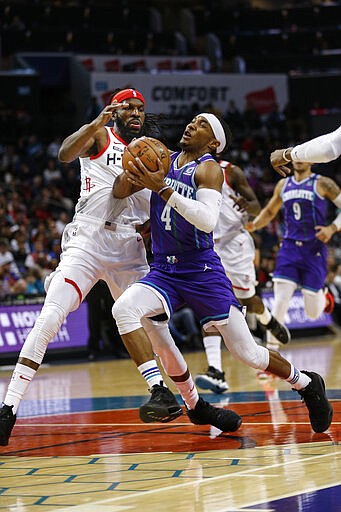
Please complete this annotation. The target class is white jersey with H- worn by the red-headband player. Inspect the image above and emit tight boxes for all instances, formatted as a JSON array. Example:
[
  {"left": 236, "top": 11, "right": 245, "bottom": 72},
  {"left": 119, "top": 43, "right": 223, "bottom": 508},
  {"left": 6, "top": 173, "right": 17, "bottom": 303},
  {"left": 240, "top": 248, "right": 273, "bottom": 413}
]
[{"left": 75, "top": 127, "right": 150, "bottom": 225}]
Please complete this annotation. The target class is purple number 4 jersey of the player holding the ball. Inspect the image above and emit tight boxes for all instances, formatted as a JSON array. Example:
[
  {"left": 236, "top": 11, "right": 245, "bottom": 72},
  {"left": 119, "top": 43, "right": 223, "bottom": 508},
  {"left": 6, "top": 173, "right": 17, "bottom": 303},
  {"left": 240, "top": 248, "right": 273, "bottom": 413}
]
[{"left": 150, "top": 152, "right": 215, "bottom": 256}]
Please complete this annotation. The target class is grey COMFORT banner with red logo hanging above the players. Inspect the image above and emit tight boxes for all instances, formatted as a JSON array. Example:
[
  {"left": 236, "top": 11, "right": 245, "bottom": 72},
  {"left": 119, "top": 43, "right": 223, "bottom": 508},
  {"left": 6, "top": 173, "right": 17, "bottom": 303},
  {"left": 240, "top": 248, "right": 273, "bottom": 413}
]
[{"left": 91, "top": 72, "right": 288, "bottom": 119}]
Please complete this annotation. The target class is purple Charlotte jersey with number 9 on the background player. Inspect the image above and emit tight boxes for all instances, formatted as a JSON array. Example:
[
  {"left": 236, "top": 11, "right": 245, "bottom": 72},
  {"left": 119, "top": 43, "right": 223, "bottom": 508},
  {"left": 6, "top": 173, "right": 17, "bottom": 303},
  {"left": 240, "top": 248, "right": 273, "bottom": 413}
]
[{"left": 281, "top": 174, "right": 327, "bottom": 241}]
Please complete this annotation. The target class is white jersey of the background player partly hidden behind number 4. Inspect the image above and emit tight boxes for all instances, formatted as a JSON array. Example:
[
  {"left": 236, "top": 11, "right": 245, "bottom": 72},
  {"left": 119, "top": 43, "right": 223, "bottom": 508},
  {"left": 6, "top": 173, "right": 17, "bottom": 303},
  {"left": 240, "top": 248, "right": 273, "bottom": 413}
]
[{"left": 213, "top": 160, "right": 249, "bottom": 242}]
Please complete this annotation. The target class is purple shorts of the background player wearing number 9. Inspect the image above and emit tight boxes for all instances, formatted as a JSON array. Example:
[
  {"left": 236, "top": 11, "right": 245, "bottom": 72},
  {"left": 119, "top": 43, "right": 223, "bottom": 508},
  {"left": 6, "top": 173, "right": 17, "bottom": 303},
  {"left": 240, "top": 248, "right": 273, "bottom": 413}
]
[{"left": 273, "top": 239, "right": 328, "bottom": 292}]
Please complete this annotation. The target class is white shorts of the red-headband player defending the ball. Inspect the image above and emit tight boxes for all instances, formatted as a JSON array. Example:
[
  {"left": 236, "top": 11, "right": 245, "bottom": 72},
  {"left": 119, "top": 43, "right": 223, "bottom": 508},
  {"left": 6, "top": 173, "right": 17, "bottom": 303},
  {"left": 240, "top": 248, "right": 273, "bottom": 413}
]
[{"left": 45, "top": 218, "right": 149, "bottom": 302}]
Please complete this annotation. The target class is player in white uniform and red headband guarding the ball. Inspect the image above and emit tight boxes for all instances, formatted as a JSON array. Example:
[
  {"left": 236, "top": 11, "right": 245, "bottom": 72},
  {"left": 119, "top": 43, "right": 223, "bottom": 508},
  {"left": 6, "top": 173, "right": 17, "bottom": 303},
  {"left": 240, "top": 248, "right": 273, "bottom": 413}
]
[{"left": 0, "top": 89, "right": 181, "bottom": 446}]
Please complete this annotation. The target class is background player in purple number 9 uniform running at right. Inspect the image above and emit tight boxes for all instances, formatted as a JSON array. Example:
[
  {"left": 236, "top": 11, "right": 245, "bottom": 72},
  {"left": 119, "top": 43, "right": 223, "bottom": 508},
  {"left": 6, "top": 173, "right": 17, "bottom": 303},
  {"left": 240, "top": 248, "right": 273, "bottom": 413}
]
[{"left": 247, "top": 162, "right": 341, "bottom": 348}]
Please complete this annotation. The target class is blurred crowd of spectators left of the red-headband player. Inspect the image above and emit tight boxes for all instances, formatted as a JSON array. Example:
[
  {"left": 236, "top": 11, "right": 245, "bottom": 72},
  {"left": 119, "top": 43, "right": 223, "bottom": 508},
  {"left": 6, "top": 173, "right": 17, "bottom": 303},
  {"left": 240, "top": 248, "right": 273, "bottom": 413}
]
[{"left": 0, "top": 134, "right": 79, "bottom": 300}]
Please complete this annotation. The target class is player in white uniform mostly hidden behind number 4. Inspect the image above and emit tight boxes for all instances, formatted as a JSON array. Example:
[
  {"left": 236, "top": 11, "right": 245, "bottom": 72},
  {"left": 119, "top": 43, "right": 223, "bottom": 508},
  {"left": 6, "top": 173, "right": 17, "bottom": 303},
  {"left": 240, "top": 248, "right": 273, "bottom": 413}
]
[{"left": 195, "top": 160, "right": 290, "bottom": 393}]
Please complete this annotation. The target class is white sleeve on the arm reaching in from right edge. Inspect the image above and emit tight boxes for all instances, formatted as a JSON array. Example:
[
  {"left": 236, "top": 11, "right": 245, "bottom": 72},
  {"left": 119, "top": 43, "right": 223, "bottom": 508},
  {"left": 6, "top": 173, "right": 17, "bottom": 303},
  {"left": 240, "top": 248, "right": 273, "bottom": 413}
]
[{"left": 291, "top": 126, "right": 341, "bottom": 163}]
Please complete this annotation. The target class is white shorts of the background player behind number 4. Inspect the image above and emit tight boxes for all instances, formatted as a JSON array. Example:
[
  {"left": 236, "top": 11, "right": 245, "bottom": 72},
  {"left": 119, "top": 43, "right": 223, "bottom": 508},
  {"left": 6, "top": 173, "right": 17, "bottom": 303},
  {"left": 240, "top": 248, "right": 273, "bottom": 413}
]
[{"left": 214, "top": 231, "right": 257, "bottom": 299}]
